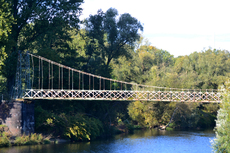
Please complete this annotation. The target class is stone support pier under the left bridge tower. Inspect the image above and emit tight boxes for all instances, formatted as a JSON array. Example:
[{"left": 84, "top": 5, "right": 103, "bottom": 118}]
[{"left": 0, "top": 101, "right": 35, "bottom": 136}]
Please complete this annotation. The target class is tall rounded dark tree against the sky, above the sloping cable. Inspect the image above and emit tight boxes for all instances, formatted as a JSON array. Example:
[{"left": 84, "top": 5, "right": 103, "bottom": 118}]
[{"left": 85, "top": 8, "right": 143, "bottom": 74}]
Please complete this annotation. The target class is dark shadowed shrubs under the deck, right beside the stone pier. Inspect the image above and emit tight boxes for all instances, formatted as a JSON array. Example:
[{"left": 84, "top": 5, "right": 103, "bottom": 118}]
[{"left": 35, "top": 100, "right": 129, "bottom": 141}]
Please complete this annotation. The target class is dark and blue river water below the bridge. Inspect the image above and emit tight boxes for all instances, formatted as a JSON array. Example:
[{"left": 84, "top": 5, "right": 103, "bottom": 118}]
[{"left": 0, "top": 129, "right": 215, "bottom": 153}]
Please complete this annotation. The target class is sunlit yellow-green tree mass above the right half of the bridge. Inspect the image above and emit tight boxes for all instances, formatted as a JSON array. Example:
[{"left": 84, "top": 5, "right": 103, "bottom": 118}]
[{"left": 112, "top": 38, "right": 230, "bottom": 89}]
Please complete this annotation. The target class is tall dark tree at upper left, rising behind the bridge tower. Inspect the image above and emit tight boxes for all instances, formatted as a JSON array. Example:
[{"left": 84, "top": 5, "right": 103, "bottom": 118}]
[{"left": 0, "top": 0, "right": 83, "bottom": 92}]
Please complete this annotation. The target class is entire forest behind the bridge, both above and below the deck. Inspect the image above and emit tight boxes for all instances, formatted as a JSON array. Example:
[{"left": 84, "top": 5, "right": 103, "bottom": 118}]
[{"left": 0, "top": 0, "right": 230, "bottom": 149}]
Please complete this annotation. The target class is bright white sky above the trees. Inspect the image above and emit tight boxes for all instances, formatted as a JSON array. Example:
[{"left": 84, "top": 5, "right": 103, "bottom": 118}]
[{"left": 80, "top": 0, "right": 230, "bottom": 57}]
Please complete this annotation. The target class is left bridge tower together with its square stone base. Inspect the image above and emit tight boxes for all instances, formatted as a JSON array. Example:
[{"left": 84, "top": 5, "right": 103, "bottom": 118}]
[{"left": 0, "top": 51, "right": 34, "bottom": 136}]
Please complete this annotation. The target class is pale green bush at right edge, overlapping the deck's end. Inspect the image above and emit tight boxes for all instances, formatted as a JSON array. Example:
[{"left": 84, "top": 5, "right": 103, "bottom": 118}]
[{"left": 212, "top": 81, "right": 230, "bottom": 153}]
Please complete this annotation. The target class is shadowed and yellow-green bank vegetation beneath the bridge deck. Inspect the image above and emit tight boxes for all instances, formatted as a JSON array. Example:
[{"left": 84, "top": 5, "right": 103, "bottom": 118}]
[{"left": 2, "top": 100, "right": 218, "bottom": 146}]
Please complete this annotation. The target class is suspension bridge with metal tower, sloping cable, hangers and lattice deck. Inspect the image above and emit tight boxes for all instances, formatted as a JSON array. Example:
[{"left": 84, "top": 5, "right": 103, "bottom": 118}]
[{"left": 12, "top": 52, "right": 222, "bottom": 103}]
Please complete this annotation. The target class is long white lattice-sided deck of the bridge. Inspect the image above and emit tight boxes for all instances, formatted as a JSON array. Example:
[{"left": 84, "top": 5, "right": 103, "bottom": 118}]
[{"left": 23, "top": 89, "right": 222, "bottom": 103}]
